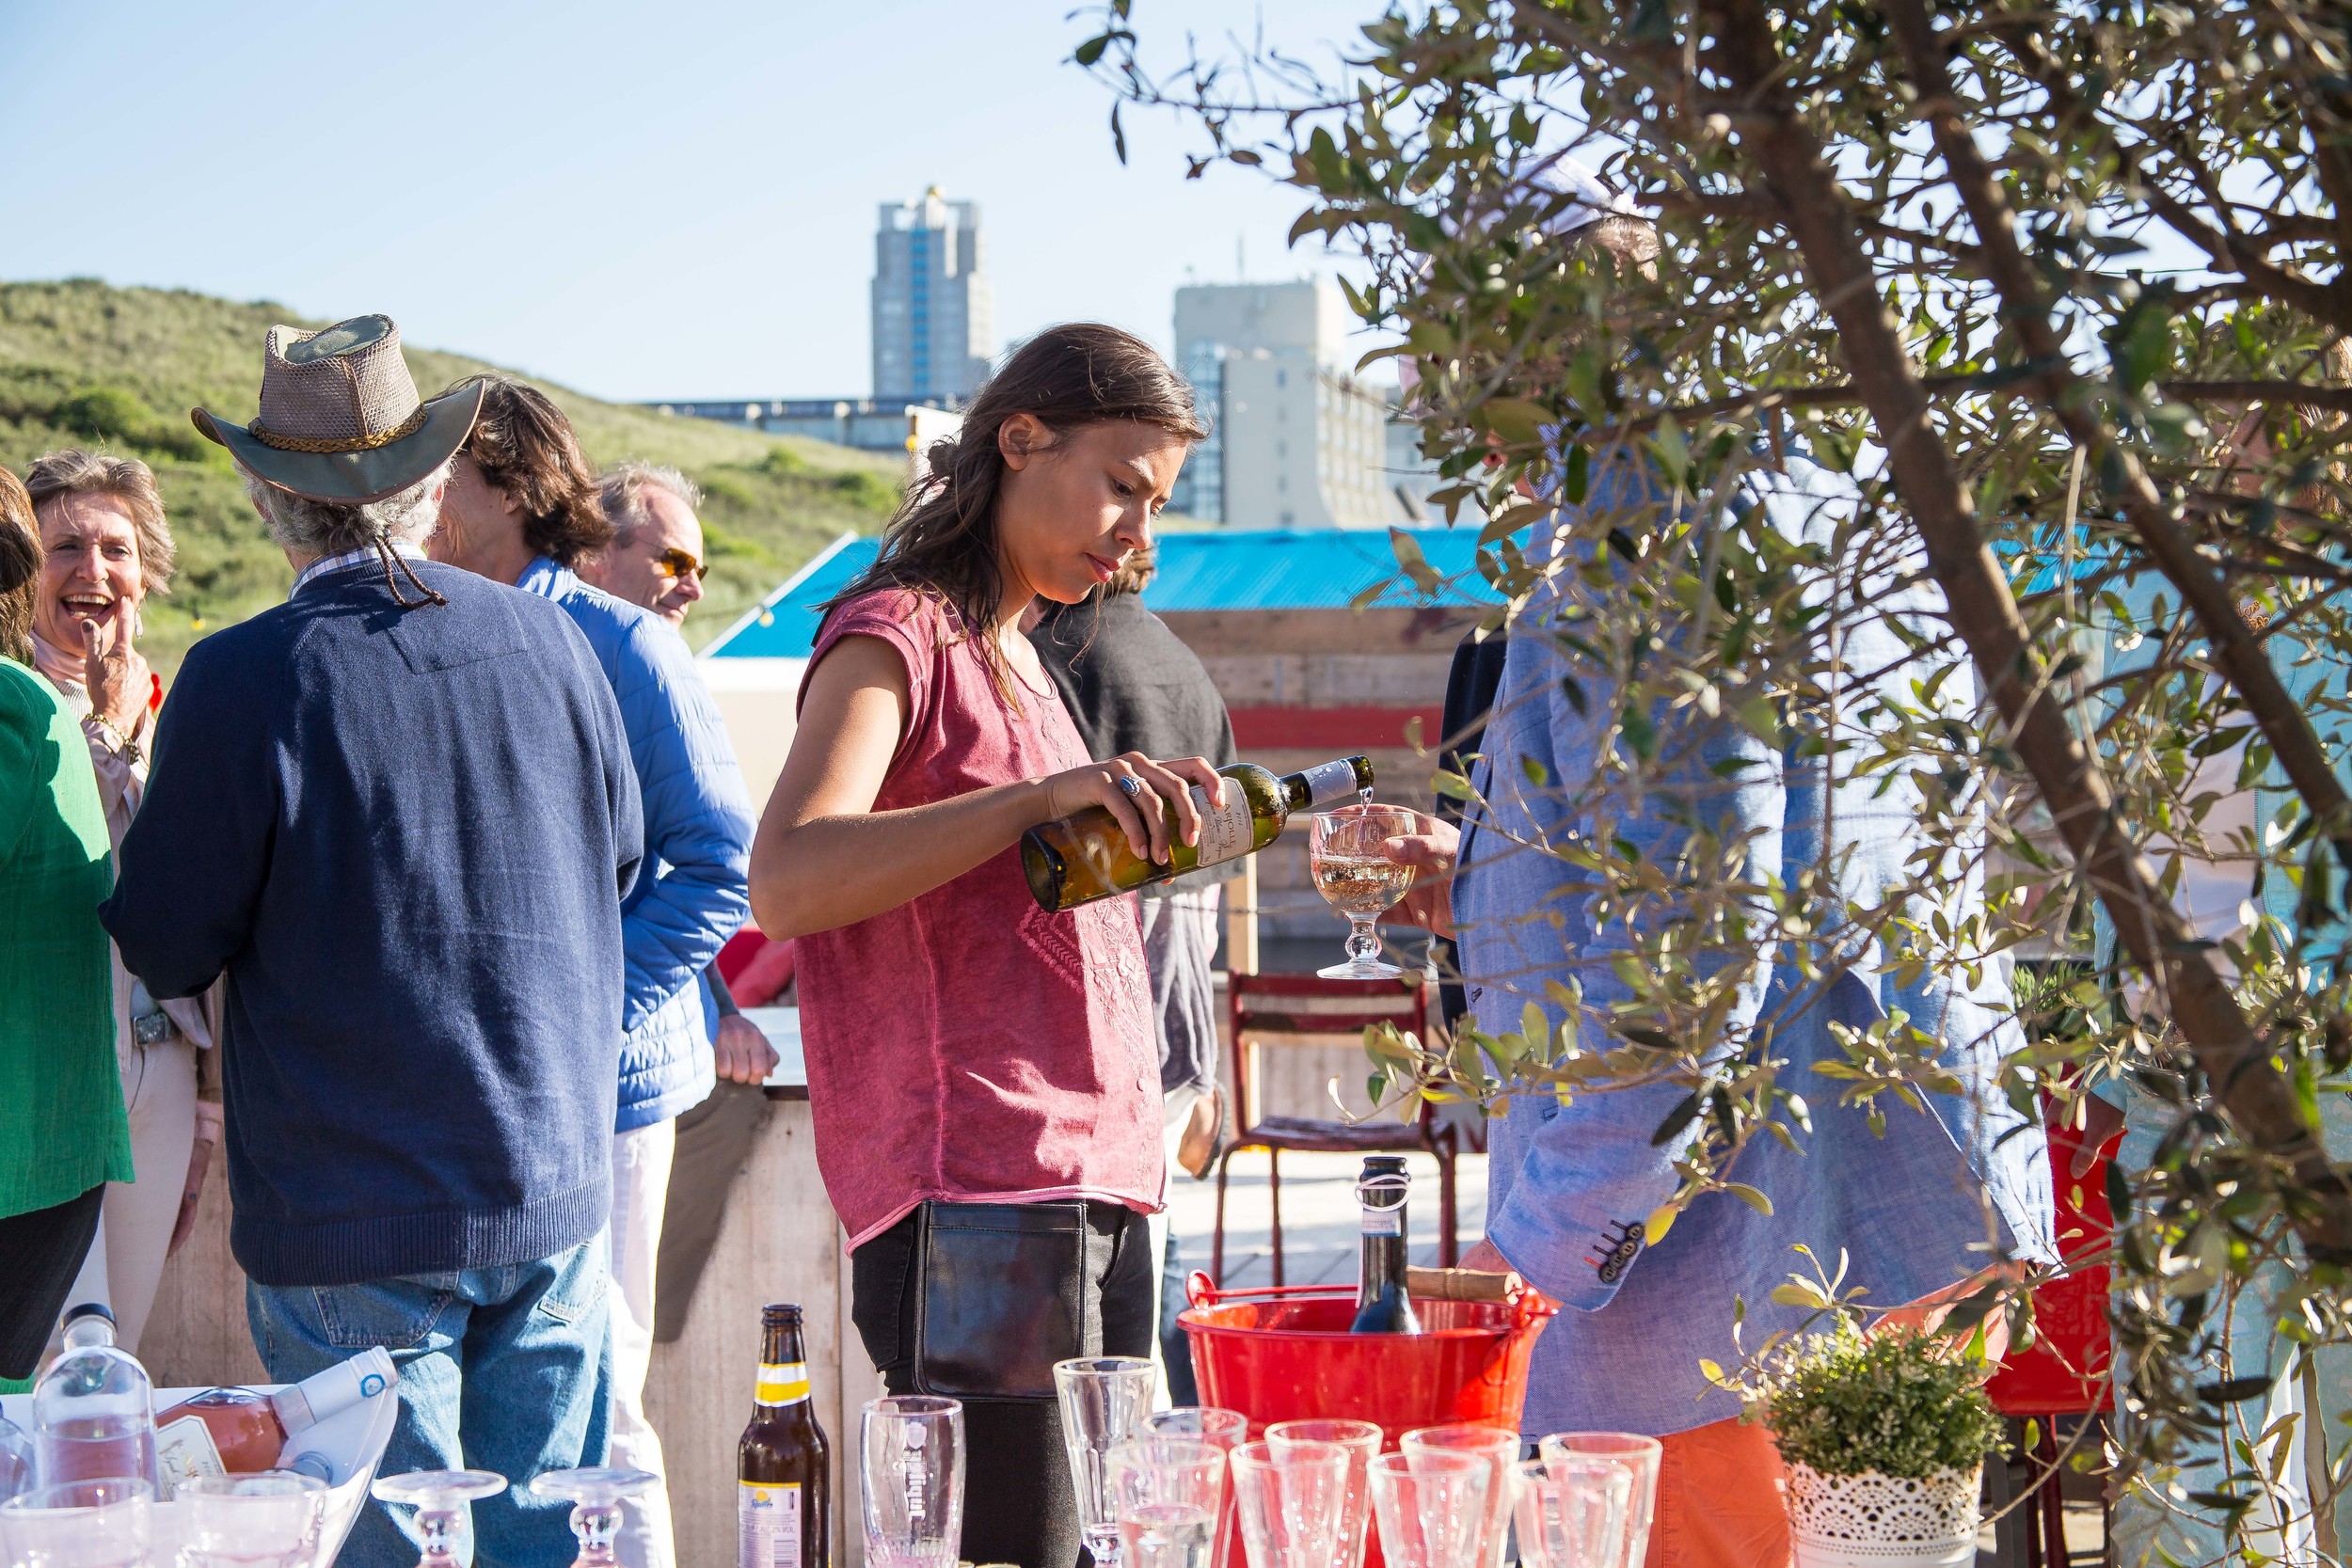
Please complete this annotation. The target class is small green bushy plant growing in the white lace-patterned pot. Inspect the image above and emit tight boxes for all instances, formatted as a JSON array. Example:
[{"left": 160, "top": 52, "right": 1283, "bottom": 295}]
[{"left": 1750, "top": 1323, "right": 2002, "bottom": 1477}]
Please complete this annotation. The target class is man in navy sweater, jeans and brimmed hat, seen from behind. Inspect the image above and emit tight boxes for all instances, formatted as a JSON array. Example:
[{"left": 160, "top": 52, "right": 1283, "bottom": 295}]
[{"left": 103, "top": 317, "right": 644, "bottom": 1568}]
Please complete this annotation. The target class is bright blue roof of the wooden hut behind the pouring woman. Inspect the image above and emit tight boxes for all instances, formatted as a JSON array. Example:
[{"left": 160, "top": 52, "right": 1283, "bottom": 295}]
[{"left": 704, "top": 524, "right": 1494, "bottom": 658}]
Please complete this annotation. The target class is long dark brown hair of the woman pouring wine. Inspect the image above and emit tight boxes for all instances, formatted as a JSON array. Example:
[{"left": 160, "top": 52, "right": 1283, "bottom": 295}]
[{"left": 823, "top": 322, "right": 1207, "bottom": 696}]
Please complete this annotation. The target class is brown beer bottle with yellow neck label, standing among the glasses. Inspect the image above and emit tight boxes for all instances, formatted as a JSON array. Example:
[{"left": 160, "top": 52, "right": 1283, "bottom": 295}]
[{"left": 737, "top": 1307, "right": 833, "bottom": 1568}]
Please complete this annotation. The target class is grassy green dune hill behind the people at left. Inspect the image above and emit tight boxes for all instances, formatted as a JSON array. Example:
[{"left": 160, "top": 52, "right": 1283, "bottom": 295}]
[{"left": 0, "top": 279, "right": 906, "bottom": 670}]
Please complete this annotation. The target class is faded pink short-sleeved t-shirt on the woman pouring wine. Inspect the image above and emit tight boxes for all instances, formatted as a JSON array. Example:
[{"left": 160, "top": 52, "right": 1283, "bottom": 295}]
[{"left": 795, "top": 590, "right": 1167, "bottom": 1246}]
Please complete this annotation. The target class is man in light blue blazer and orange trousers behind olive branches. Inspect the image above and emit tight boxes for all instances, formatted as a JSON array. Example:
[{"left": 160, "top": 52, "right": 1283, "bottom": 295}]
[{"left": 1383, "top": 444, "right": 2056, "bottom": 1568}]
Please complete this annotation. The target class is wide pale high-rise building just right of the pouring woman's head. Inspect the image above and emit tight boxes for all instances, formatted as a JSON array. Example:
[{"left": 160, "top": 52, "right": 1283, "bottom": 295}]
[{"left": 1169, "top": 277, "right": 1411, "bottom": 529}]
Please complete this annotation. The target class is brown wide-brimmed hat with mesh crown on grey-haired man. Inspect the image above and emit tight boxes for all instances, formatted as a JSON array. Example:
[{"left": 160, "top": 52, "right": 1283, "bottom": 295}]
[{"left": 188, "top": 315, "right": 483, "bottom": 505}]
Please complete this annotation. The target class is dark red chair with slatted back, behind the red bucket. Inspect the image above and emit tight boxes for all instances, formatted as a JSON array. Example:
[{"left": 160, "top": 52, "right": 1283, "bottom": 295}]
[{"left": 1209, "top": 974, "right": 1461, "bottom": 1286}]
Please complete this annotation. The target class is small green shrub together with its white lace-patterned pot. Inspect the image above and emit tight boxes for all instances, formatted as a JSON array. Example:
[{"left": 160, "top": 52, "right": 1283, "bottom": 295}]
[{"left": 1753, "top": 1322, "right": 2002, "bottom": 1568}]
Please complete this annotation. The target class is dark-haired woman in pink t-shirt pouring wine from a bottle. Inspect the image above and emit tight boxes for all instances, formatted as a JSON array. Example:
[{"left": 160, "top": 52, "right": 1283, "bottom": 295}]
[{"left": 751, "top": 325, "right": 1232, "bottom": 1568}]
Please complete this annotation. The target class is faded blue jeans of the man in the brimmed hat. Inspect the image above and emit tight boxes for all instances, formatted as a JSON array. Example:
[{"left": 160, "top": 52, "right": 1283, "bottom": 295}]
[{"left": 245, "top": 1234, "right": 612, "bottom": 1568}]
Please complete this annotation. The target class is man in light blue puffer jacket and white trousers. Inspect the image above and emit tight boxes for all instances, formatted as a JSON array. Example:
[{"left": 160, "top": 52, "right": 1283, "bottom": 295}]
[{"left": 431, "top": 376, "right": 753, "bottom": 1568}]
